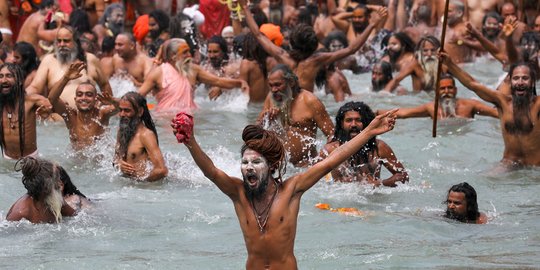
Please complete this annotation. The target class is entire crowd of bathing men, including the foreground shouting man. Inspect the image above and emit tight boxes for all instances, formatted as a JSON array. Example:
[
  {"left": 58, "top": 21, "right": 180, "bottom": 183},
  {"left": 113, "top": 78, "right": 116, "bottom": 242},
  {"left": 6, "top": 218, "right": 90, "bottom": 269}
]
[{"left": 0, "top": 0, "right": 540, "bottom": 269}]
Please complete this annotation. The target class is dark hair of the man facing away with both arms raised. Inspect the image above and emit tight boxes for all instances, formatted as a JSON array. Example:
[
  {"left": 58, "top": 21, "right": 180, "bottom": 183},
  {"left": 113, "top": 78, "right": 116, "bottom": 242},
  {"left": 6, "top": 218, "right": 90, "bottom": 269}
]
[{"left": 289, "top": 23, "right": 319, "bottom": 61}]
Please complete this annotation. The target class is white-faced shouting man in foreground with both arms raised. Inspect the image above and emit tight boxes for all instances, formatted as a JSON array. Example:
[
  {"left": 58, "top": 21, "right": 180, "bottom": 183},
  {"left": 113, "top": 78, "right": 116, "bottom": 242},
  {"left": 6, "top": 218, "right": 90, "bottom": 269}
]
[{"left": 173, "top": 108, "right": 395, "bottom": 269}]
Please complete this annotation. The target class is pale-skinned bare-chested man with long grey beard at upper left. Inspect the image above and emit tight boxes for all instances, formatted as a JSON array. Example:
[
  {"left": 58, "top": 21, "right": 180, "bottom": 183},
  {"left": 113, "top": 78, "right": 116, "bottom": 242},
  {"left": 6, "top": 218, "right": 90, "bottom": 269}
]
[{"left": 26, "top": 25, "right": 112, "bottom": 108}]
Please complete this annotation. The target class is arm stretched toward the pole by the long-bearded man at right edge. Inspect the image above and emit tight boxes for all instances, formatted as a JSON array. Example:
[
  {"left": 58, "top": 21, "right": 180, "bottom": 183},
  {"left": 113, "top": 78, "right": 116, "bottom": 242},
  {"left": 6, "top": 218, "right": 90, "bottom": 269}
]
[{"left": 439, "top": 52, "right": 506, "bottom": 107}]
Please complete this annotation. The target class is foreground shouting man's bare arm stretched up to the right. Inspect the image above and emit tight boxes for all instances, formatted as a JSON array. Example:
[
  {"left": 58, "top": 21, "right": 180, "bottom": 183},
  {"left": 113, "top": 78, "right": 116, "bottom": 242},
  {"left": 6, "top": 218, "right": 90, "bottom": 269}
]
[{"left": 289, "top": 110, "right": 396, "bottom": 193}]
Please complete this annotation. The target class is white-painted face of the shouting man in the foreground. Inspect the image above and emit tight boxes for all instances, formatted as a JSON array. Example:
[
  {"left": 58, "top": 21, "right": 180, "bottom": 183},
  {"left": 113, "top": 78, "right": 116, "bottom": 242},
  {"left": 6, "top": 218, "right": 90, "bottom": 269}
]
[{"left": 240, "top": 148, "right": 270, "bottom": 190}]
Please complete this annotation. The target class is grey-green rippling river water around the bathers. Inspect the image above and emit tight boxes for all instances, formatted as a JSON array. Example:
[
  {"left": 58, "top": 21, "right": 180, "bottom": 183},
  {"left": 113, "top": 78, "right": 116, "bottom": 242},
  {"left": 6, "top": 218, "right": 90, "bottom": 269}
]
[{"left": 0, "top": 60, "right": 540, "bottom": 269}]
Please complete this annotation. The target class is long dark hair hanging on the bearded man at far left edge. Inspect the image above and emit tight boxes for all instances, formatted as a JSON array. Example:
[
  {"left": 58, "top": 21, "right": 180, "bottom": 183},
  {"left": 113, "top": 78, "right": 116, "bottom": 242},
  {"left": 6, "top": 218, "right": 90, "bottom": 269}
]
[{"left": 0, "top": 63, "right": 26, "bottom": 156}]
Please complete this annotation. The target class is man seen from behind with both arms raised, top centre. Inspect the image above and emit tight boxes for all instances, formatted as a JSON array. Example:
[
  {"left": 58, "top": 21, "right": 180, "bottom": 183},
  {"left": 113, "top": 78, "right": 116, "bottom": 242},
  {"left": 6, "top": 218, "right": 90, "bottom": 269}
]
[{"left": 239, "top": 0, "right": 387, "bottom": 92}]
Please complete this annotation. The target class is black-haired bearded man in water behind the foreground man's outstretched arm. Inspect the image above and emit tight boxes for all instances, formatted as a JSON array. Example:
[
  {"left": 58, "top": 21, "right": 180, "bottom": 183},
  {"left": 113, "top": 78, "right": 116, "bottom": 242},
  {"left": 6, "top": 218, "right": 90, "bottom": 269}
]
[{"left": 320, "top": 102, "right": 409, "bottom": 187}]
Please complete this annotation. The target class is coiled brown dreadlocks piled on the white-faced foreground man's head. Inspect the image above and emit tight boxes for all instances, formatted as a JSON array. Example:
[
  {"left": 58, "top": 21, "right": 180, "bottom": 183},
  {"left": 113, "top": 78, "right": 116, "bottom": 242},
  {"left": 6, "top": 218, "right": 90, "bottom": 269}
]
[{"left": 240, "top": 125, "right": 286, "bottom": 183}]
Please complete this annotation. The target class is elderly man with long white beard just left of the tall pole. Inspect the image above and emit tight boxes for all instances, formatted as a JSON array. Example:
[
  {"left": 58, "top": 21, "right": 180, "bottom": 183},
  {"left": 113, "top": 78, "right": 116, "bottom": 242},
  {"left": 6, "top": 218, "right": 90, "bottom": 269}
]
[{"left": 384, "top": 36, "right": 441, "bottom": 92}]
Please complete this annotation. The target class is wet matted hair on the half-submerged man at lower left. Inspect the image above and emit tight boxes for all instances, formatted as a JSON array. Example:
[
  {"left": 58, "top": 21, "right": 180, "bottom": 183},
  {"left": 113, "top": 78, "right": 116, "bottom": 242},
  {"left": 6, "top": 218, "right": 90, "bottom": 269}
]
[{"left": 15, "top": 157, "right": 60, "bottom": 201}]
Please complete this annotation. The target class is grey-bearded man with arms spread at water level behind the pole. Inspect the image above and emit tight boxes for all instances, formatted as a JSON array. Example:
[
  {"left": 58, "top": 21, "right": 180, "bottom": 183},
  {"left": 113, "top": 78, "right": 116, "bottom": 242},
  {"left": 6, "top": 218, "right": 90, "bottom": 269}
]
[{"left": 377, "top": 74, "right": 498, "bottom": 119}]
